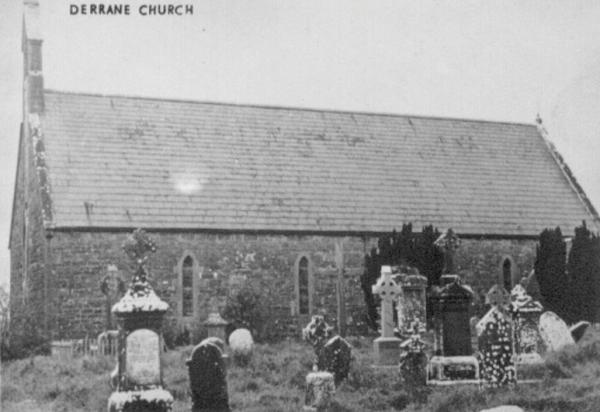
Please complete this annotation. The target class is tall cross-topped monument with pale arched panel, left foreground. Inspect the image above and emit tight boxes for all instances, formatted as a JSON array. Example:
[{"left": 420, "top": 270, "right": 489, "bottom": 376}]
[{"left": 108, "top": 229, "right": 173, "bottom": 412}]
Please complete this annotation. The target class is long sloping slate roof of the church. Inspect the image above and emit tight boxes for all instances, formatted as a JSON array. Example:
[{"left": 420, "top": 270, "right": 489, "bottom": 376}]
[{"left": 41, "top": 91, "right": 597, "bottom": 236}]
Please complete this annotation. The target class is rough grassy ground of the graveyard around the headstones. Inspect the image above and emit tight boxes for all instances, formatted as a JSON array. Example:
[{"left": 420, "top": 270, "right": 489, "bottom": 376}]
[{"left": 1, "top": 327, "right": 600, "bottom": 412}]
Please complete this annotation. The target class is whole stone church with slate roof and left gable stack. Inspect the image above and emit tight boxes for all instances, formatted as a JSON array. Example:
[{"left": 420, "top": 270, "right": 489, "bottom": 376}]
[{"left": 10, "top": 0, "right": 600, "bottom": 339}]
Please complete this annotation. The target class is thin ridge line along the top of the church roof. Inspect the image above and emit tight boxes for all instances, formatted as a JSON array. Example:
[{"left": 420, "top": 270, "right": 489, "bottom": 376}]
[{"left": 44, "top": 89, "right": 536, "bottom": 127}]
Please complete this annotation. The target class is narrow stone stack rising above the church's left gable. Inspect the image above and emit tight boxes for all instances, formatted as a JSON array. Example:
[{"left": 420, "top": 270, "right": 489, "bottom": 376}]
[{"left": 21, "top": 0, "right": 44, "bottom": 113}]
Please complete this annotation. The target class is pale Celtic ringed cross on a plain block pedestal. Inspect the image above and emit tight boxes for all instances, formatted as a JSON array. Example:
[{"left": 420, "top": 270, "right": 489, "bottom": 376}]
[{"left": 372, "top": 266, "right": 402, "bottom": 365}]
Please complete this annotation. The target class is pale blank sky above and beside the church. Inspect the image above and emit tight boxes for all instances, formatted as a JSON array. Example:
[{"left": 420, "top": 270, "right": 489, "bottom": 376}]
[{"left": 0, "top": 0, "right": 600, "bottom": 290}]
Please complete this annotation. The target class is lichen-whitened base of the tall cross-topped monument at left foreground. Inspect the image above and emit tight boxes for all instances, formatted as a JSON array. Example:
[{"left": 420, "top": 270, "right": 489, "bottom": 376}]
[{"left": 108, "top": 389, "right": 173, "bottom": 412}]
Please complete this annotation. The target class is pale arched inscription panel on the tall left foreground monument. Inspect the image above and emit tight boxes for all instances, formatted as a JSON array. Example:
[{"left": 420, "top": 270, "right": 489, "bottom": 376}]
[{"left": 125, "top": 329, "right": 160, "bottom": 385}]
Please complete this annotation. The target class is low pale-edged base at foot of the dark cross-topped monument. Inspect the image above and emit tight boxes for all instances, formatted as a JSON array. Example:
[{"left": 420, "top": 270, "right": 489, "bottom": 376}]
[{"left": 427, "top": 356, "right": 479, "bottom": 383}]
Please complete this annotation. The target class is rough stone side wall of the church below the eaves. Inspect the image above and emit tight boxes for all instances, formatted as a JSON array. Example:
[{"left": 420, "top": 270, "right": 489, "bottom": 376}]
[{"left": 44, "top": 232, "right": 536, "bottom": 339}]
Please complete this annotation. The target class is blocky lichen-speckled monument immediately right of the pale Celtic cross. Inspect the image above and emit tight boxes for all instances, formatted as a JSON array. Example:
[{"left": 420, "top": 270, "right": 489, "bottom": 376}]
[{"left": 396, "top": 275, "right": 427, "bottom": 336}]
